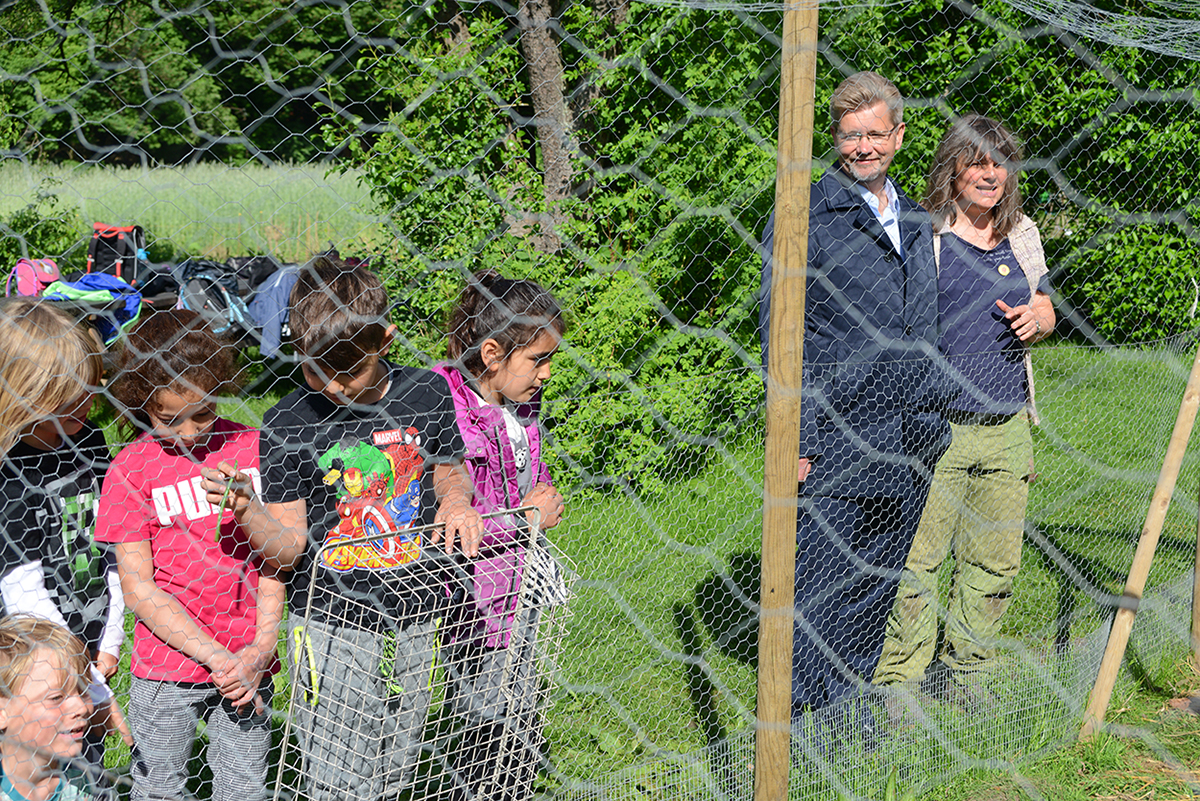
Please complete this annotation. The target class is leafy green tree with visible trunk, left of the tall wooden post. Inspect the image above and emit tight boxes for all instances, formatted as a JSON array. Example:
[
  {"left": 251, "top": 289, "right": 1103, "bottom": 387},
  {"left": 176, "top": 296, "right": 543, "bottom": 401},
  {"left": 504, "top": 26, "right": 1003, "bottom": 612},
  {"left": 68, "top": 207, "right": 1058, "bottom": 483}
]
[{"left": 326, "top": 2, "right": 778, "bottom": 493}]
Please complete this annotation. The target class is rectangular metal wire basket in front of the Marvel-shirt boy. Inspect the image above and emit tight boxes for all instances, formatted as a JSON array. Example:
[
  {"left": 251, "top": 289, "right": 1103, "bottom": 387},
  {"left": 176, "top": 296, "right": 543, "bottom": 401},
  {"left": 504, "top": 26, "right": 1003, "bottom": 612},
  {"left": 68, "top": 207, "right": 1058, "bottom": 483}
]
[{"left": 272, "top": 507, "right": 577, "bottom": 801}]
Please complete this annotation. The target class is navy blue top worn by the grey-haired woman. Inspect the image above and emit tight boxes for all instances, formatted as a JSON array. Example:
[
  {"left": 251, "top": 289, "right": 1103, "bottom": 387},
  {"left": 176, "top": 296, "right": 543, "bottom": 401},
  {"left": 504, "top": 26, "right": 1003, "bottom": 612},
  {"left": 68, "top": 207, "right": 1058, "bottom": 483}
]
[{"left": 937, "top": 234, "right": 1050, "bottom": 415}]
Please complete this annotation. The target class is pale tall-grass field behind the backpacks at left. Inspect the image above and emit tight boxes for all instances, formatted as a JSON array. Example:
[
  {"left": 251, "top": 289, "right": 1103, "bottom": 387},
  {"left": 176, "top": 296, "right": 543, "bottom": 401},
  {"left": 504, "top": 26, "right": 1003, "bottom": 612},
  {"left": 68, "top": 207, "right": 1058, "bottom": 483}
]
[{"left": 0, "top": 162, "right": 379, "bottom": 261}]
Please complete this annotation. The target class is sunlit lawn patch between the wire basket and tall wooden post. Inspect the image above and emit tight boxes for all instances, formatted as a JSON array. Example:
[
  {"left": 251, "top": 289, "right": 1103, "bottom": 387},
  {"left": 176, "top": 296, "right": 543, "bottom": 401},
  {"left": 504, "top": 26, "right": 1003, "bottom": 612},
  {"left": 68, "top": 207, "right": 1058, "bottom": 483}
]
[{"left": 548, "top": 438, "right": 762, "bottom": 777}]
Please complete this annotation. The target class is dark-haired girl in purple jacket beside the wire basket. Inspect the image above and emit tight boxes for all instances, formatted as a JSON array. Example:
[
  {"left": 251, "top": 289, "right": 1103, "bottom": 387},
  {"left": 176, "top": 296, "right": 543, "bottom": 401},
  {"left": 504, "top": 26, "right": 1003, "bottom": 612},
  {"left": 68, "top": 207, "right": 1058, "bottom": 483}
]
[{"left": 433, "top": 270, "right": 565, "bottom": 801}]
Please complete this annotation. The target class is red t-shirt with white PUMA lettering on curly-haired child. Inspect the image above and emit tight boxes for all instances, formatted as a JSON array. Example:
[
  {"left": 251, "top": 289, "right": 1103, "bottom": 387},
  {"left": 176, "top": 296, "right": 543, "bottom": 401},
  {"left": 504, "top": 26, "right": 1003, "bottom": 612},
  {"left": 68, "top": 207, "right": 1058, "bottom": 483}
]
[{"left": 96, "top": 418, "right": 278, "bottom": 682}]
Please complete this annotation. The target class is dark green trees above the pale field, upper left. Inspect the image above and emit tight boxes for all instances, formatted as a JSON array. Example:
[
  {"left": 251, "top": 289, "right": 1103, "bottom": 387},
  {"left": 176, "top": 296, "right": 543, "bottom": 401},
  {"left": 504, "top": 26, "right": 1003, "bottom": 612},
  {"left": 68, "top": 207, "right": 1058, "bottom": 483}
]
[{"left": 0, "top": 0, "right": 413, "bottom": 164}]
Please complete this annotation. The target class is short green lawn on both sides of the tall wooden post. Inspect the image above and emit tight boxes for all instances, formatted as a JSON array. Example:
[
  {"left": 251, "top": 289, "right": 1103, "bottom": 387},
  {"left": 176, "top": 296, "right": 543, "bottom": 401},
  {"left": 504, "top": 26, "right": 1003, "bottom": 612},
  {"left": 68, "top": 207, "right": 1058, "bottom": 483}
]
[{"left": 96, "top": 347, "right": 1200, "bottom": 801}]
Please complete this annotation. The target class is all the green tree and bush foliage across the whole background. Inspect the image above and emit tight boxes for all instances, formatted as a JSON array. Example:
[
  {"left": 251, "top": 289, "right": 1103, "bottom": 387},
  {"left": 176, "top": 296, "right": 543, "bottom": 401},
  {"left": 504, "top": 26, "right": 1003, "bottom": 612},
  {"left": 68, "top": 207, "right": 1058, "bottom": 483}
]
[{"left": 0, "top": 0, "right": 1200, "bottom": 492}]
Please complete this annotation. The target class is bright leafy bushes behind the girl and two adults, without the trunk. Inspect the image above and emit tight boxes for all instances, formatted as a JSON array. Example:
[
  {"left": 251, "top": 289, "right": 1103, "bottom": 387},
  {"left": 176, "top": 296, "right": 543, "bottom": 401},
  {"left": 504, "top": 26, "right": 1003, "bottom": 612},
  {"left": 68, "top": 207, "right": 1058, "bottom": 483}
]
[{"left": 326, "top": 0, "right": 1200, "bottom": 490}]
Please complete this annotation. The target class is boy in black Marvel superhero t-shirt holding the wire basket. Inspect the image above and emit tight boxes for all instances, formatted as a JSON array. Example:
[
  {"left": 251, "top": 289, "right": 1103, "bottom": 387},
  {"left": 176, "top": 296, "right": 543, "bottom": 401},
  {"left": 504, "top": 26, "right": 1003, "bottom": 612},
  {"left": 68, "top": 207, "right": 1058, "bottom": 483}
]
[{"left": 206, "top": 257, "right": 482, "bottom": 801}]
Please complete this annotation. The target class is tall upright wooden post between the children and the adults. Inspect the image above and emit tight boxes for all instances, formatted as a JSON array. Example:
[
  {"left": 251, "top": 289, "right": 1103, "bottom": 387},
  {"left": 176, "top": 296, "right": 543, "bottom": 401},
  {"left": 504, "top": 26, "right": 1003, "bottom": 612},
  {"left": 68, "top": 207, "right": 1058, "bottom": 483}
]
[{"left": 754, "top": 0, "right": 817, "bottom": 801}]
